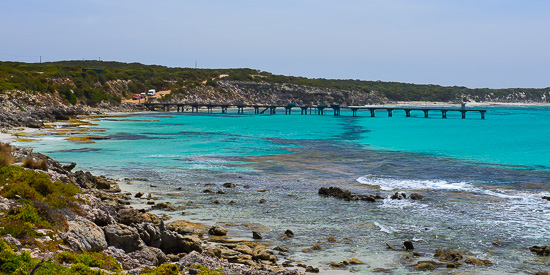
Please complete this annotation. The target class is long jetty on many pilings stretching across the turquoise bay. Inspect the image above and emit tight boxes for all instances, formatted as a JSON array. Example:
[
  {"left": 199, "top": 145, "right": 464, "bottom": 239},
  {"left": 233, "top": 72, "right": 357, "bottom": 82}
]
[{"left": 138, "top": 102, "right": 487, "bottom": 119}]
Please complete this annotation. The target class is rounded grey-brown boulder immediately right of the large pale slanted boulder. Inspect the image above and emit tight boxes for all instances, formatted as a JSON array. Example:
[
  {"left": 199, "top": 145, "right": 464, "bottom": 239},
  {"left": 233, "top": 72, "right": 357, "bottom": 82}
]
[{"left": 105, "top": 224, "right": 145, "bottom": 252}]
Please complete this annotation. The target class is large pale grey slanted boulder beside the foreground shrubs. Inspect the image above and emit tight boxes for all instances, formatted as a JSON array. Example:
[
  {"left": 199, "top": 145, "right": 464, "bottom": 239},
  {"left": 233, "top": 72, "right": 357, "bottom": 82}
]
[{"left": 61, "top": 216, "right": 107, "bottom": 252}]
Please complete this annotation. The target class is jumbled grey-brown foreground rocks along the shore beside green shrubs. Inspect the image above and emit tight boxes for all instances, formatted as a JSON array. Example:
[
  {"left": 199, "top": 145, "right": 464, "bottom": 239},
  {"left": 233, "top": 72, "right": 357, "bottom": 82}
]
[{"left": 0, "top": 144, "right": 318, "bottom": 274}]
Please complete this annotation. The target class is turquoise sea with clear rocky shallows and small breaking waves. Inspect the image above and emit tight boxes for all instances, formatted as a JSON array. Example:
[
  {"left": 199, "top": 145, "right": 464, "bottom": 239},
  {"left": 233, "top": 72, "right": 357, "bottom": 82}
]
[{"left": 18, "top": 107, "right": 550, "bottom": 274}]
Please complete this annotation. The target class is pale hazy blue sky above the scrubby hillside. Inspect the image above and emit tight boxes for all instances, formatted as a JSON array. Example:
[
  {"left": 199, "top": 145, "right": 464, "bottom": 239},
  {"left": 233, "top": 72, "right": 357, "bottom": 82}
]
[{"left": 0, "top": 0, "right": 550, "bottom": 88}]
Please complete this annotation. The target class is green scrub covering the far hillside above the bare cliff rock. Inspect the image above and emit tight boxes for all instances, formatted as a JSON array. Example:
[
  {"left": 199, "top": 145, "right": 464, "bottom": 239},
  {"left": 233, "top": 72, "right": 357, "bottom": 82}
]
[{"left": 0, "top": 61, "right": 550, "bottom": 106}]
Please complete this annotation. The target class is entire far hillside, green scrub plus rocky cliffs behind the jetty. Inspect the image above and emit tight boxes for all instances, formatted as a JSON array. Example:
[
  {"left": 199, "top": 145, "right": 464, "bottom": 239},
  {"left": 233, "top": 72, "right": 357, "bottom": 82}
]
[{"left": 0, "top": 61, "right": 550, "bottom": 106}]
